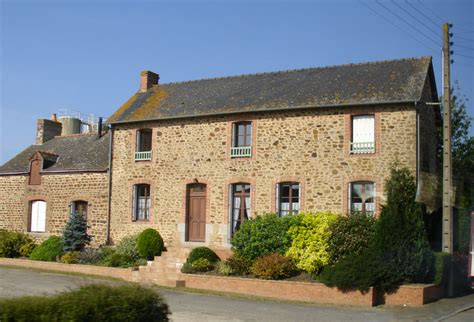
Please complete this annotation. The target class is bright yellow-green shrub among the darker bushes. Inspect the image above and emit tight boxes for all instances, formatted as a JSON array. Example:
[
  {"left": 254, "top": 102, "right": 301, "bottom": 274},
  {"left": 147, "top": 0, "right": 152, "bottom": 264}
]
[{"left": 286, "top": 212, "right": 339, "bottom": 274}]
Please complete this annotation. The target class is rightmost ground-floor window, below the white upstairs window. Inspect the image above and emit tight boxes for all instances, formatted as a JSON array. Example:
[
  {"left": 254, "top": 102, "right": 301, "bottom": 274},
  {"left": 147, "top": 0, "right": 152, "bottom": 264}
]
[{"left": 349, "top": 181, "right": 375, "bottom": 216}]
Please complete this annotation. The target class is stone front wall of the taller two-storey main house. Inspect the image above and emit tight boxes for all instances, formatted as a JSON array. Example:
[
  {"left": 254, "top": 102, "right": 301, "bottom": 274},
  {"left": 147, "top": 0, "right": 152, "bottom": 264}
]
[{"left": 111, "top": 105, "right": 417, "bottom": 249}]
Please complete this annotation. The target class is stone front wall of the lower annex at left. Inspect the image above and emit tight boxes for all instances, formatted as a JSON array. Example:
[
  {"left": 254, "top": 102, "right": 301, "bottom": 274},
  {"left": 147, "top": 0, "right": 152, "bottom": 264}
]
[{"left": 0, "top": 172, "right": 108, "bottom": 246}]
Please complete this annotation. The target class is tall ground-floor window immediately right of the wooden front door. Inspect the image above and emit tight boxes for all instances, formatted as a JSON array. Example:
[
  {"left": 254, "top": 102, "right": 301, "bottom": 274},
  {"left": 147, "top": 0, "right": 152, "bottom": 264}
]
[{"left": 230, "top": 183, "right": 251, "bottom": 236}]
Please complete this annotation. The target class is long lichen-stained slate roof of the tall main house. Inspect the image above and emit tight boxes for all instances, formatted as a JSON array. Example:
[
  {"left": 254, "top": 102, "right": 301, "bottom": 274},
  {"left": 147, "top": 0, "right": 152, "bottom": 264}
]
[{"left": 108, "top": 57, "right": 436, "bottom": 124}]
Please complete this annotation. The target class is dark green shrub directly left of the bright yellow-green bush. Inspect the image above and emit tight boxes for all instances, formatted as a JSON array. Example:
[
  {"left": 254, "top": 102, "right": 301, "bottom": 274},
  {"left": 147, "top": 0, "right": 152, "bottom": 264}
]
[{"left": 231, "top": 214, "right": 298, "bottom": 261}]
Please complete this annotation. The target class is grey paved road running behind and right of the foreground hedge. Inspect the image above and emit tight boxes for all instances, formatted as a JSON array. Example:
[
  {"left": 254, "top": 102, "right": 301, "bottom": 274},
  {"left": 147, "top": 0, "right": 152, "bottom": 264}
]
[{"left": 0, "top": 267, "right": 474, "bottom": 322}]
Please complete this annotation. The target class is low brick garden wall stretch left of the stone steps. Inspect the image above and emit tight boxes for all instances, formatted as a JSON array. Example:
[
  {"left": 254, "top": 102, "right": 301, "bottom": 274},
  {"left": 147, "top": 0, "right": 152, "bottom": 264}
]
[{"left": 0, "top": 258, "right": 133, "bottom": 282}]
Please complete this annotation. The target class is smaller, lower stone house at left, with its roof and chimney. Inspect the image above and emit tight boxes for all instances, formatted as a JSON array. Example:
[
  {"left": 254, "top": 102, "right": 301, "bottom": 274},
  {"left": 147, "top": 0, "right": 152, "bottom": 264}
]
[{"left": 0, "top": 119, "right": 110, "bottom": 245}]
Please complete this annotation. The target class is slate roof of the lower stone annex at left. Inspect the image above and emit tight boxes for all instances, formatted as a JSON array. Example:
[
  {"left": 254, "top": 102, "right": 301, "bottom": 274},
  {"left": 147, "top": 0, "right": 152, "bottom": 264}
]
[{"left": 0, "top": 133, "right": 110, "bottom": 175}]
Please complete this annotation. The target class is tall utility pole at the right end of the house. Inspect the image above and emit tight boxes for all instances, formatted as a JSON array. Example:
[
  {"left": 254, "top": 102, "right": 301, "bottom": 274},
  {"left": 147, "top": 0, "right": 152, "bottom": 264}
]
[{"left": 442, "top": 23, "right": 454, "bottom": 296}]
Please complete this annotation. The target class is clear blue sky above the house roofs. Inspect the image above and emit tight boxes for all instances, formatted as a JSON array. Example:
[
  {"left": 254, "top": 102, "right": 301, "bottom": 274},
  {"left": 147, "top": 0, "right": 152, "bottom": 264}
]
[{"left": 0, "top": 0, "right": 474, "bottom": 164}]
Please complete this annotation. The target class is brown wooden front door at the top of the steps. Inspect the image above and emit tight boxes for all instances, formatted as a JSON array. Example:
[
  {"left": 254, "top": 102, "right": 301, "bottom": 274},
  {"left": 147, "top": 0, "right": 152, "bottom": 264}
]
[{"left": 186, "top": 184, "right": 206, "bottom": 242}]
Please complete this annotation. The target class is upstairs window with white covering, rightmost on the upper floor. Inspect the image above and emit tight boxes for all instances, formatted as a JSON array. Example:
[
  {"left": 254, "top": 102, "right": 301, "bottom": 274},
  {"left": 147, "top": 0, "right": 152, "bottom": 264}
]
[{"left": 351, "top": 115, "right": 375, "bottom": 154}]
